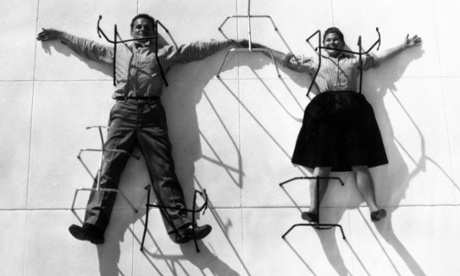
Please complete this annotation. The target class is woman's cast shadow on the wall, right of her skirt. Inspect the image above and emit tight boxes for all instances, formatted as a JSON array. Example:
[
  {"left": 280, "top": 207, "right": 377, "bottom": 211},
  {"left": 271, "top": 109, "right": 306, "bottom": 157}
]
[{"left": 336, "top": 48, "right": 426, "bottom": 275}]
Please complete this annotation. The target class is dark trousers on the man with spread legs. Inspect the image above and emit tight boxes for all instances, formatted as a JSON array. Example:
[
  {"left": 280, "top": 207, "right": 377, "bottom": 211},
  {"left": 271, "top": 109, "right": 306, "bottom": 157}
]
[{"left": 85, "top": 99, "right": 191, "bottom": 232}]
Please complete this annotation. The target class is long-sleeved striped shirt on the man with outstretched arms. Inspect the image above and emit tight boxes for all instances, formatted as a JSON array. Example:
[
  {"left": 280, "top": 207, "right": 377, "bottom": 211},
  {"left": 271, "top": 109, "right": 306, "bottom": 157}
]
[{"left": 59, "top": 32, "right": 230, "bottom": 99}]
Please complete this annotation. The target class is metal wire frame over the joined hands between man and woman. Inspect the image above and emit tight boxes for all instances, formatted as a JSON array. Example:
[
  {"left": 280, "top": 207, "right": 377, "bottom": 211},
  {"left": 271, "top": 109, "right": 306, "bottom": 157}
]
[{"left": 217, "top": 0, "right": 281, "bottom": 78}]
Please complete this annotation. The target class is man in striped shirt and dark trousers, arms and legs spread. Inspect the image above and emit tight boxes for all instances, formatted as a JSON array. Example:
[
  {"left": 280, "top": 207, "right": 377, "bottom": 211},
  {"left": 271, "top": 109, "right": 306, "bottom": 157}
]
[{"left": 37, "top": 14, "right": 238, "bottom": 244}]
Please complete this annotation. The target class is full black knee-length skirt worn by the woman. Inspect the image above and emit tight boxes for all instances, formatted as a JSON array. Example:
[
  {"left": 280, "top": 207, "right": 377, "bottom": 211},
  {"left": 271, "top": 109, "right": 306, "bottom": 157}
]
[{"left": 292, "top": 91, "right": 388, "bottom": 171}]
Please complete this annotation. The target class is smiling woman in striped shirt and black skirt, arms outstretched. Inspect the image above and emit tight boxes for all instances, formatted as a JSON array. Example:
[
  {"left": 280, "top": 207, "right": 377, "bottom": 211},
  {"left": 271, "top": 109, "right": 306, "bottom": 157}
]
[{"left": 253, "top": 27, "right": 422, "bottom": 223}]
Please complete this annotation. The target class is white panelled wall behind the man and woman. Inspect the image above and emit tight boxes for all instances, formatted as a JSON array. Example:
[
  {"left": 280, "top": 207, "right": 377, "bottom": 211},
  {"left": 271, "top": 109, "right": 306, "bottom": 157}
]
[{"left": 0, "top": 0, "right": 460, "bottom": 276}]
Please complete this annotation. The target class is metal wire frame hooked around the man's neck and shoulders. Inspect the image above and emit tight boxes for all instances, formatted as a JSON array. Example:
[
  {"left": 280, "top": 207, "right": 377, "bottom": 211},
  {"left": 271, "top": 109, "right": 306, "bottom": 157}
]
[{"left": 97, "top": 15, "right": 171, "bottom": 86}]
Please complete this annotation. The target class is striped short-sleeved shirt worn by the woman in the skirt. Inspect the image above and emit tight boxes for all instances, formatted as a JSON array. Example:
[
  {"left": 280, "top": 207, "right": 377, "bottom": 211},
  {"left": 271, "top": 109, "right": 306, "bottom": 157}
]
[{"left": 283, "top": 53, "right": 380, "bottom": 92}]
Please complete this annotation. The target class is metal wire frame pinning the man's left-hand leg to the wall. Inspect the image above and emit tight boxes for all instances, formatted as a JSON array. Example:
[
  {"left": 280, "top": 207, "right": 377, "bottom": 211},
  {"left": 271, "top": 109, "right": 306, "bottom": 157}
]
[{"left": 70, "top": 126, "right": 140, "bottom": 213}]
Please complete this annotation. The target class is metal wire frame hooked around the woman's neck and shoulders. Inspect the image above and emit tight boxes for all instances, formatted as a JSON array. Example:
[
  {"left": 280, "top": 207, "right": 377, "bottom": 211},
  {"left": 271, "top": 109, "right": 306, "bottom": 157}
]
[{"left": 306, "top": 28, "right": 381, "bottom": 97}]
